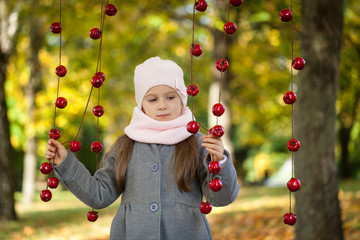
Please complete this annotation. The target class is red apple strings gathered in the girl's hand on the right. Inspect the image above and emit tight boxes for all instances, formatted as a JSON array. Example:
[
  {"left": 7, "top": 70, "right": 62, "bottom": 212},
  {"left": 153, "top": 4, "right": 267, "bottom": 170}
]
[{"left": 187, "top": 0, "right": 243, "bottom": 214}]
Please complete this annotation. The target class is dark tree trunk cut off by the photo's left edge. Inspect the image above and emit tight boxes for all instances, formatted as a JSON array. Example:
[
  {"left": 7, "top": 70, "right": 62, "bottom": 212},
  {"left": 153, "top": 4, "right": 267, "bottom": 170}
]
[{"left": 0, "top": 0, "right": 18, "bottom": 221}]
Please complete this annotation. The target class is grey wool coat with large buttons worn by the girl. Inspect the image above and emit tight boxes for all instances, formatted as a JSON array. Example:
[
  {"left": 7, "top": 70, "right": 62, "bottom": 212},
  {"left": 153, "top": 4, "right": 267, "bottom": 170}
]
[{"left": 55, "top": 133, "right": 239, "bottom": 240}]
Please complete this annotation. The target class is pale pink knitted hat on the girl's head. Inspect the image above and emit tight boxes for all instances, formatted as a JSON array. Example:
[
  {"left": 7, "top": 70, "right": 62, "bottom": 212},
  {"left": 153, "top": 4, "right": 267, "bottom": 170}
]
[{"left": 134, "top": 57, "right": 187, "bottom": 109}]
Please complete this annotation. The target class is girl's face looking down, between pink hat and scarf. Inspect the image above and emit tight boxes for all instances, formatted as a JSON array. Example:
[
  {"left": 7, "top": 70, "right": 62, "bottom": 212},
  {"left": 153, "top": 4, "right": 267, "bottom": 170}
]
[{"left": 142, "top": 85, "right": 183, "bottom": 121}]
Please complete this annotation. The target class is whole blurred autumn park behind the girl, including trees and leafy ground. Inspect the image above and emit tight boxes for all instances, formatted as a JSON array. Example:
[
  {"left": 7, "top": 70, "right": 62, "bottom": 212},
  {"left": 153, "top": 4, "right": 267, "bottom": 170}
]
[{"left": 0, "top": 0, "right": 360, "bottom": 240}]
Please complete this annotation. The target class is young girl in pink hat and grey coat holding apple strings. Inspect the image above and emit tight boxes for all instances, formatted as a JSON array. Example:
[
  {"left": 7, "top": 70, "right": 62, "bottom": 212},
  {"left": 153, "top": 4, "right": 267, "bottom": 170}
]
[{"left": 46, "top": 57, "right": 239, "bottom": 240}]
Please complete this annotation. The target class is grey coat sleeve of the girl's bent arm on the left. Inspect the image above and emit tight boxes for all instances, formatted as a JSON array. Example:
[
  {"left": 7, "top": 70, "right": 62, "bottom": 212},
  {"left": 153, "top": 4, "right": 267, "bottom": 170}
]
[{"left": 54, "top": 151, "right": 120, "bottom": 209}]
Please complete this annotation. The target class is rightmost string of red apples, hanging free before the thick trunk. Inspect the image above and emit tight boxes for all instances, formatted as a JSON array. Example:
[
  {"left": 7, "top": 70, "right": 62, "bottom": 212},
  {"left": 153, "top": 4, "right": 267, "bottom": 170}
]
[{"left": 279, "top": 0, "right": 305, "bottom": 226}]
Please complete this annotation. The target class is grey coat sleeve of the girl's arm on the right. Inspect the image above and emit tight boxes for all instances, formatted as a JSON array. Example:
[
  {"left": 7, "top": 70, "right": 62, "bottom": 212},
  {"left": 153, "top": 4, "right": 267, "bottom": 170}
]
[{"left": 196, "top": 134, "right": 240, "bottom": 207}]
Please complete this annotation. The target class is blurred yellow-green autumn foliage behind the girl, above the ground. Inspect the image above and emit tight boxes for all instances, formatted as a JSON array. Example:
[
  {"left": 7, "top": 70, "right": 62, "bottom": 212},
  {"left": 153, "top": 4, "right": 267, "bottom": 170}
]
[{"left": 0, "top": 0, "right": 360, "bottom": 234}]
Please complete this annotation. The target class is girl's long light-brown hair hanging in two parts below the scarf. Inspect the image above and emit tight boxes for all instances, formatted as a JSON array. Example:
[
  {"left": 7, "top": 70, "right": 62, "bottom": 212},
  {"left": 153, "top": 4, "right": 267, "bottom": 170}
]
[{"left": 110, "top": 134, "right": 199, "bottom": 193}]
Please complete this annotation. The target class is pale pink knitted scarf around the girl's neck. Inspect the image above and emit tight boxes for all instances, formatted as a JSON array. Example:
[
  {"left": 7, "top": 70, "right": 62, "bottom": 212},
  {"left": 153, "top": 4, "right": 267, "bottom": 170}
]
[{"left": 125, "top": 106, "right": 192, "bottom": 145}]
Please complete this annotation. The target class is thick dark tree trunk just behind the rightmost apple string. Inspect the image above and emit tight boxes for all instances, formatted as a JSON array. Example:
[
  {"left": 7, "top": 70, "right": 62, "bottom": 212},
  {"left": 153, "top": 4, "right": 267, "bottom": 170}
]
[{"left": 294, "top": 0, "right": 344, "bottom": 240}]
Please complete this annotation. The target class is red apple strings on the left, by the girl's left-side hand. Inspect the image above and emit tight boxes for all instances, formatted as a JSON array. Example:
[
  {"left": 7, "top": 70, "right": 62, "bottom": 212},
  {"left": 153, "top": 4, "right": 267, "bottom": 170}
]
[{"left": 40, "top": 0, "right": 117, "bottom": 222}]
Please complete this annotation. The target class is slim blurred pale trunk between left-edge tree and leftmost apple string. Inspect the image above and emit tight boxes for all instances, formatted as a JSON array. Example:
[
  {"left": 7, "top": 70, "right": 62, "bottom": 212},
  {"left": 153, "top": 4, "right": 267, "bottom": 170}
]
[{"left": 22, "top": 1, "right": 44, "bottom": 206}]
